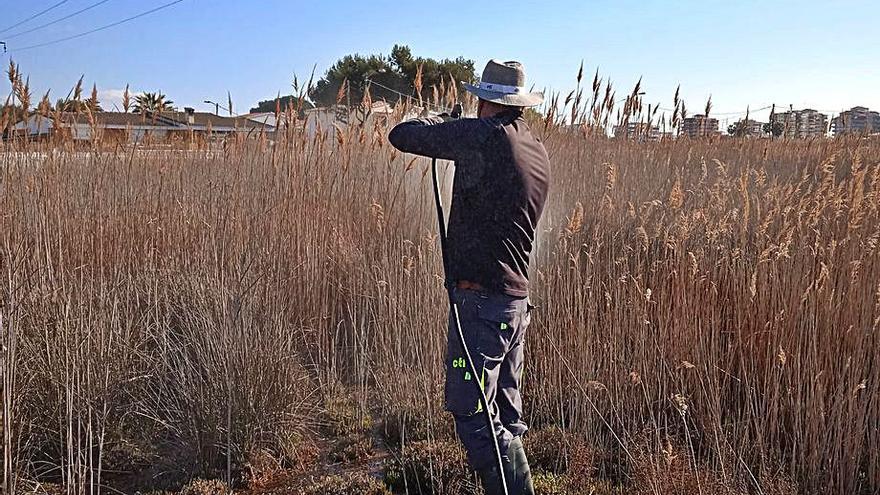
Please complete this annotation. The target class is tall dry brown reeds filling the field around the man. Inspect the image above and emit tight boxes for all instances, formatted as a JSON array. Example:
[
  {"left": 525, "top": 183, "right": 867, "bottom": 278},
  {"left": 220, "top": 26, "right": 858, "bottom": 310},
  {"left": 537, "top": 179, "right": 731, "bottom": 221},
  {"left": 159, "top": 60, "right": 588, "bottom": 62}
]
[{"left": 0, "top": 67, "right": 880, "bottom": 493}]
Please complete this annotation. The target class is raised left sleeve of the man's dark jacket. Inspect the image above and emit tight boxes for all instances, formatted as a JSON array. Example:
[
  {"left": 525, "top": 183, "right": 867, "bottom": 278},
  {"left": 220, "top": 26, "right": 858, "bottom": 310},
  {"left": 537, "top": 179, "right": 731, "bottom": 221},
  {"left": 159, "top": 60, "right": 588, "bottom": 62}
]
[{"left": 388, "top": 117, "right": 494, "bottom": 161}]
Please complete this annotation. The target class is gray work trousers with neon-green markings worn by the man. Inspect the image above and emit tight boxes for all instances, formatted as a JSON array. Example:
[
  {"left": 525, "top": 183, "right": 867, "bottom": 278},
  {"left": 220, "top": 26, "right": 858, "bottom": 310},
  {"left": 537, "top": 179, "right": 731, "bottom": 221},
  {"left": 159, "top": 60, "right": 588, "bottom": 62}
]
[{"left": 446, "top": 289, "right": 531, "bottom": 470}]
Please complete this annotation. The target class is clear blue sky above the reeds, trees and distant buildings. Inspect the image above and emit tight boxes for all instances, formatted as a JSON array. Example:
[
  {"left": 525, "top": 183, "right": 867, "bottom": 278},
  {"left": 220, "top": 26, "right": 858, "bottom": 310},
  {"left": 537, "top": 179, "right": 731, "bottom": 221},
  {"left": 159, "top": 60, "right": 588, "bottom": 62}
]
[{"left": 0, "top": 0, "right": 880, "bottom": 124}]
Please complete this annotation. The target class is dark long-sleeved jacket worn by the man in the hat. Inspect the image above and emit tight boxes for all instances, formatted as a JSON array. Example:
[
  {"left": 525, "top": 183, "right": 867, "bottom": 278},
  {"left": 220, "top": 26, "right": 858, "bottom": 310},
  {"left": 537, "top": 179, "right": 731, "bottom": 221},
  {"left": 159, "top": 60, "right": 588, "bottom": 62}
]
[{"left": 388, "top": 110, "right": 550, "bottom": 297}]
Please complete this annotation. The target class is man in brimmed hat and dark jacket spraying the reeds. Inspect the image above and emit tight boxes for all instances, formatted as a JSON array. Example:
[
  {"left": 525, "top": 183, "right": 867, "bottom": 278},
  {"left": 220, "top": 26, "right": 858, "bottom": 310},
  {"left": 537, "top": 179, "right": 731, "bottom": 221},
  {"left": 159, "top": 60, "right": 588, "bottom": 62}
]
[{"left": 388, "top": 60, "right": 550, "bottom": 495}]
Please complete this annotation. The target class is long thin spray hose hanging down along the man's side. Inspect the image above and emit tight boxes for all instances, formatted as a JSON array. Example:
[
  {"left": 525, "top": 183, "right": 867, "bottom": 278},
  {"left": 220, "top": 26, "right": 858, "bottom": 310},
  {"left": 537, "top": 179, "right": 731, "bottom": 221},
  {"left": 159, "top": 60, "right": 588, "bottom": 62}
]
[{"left": 431, "top": 103, "right": 508, "bottom": 495}]
